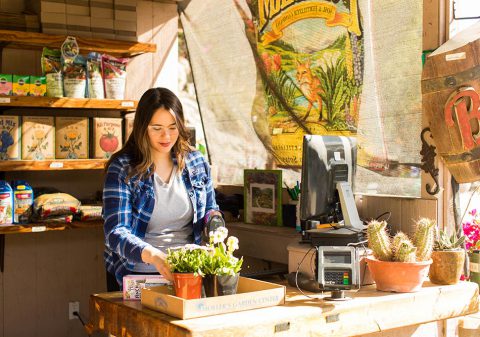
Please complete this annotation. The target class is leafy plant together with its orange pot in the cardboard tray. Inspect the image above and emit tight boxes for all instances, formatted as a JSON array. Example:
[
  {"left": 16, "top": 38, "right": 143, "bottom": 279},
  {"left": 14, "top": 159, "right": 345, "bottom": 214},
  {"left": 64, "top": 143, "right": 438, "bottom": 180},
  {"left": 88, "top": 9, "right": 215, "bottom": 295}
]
[{"left": 167, "top": 244, "right": 208, "bottom": 299}]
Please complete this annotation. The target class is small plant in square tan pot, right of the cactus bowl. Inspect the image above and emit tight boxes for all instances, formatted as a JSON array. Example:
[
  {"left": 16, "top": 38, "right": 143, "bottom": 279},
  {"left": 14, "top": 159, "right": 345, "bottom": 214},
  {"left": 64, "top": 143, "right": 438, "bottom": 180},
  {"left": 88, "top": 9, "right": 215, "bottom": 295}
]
[{"left": 428, "top": 226, "right": 465, "bottom": 284}]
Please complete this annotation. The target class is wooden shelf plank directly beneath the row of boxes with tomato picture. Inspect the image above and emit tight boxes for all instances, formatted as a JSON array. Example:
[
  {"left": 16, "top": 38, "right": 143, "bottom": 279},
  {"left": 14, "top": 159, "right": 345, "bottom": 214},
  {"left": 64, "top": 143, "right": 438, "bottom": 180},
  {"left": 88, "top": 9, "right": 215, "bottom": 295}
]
[{"left": 0, "top": 159, "right": 107, "bottom": 171}]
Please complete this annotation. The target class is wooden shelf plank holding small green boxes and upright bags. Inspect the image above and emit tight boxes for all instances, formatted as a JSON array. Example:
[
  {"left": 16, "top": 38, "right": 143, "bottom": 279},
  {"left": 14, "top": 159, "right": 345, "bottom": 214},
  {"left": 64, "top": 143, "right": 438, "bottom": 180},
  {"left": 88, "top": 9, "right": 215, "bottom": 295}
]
[{"left": 0, "top": 96, "right": 138, "bottom": 111}]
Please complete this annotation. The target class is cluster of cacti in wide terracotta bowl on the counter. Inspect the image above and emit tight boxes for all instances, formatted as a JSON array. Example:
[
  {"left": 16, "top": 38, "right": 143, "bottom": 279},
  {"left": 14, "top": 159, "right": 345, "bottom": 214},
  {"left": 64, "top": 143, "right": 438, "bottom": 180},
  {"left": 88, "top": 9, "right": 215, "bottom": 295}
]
[{"left": 367, "top": 218, "right": 435, "bottom": 292}]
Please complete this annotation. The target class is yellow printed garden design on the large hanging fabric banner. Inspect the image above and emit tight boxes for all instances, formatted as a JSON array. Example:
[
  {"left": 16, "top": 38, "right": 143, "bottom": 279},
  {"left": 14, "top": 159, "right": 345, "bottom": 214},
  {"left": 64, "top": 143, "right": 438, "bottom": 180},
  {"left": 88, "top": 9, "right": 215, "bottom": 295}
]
[{"left": 237, "top": 0, "right": 363, "bottom": 167}]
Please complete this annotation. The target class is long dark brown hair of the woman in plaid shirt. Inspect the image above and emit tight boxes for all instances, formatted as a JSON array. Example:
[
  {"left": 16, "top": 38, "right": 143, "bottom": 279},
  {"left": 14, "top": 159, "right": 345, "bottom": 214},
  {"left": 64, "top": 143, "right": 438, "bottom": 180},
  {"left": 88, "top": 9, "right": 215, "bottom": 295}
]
[{"left": 105, "top": 88, "right": 191, "bottom": 182}]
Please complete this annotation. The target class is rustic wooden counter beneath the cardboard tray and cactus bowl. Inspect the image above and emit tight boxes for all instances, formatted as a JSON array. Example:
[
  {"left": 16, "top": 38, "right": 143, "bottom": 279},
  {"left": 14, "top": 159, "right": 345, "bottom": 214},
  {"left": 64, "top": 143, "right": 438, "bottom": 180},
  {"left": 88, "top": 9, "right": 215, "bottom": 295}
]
[{"left": 90, "top": 282, "right": 479, "bottom": 337}]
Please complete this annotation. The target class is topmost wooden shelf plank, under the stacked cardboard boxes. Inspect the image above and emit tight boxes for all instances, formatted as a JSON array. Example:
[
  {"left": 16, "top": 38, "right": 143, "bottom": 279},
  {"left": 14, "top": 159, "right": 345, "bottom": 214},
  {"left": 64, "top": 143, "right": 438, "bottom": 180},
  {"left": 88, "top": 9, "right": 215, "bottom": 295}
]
[{"left": 0, "top": 30, "right": 157, "bottom": 57}]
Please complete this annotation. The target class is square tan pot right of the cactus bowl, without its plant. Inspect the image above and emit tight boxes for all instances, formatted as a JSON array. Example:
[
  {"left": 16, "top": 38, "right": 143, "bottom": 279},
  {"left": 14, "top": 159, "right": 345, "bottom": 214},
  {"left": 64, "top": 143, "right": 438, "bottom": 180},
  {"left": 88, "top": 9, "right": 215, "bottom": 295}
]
[{"left": 428, "top": 249, "right": 465, "bottom": 284}]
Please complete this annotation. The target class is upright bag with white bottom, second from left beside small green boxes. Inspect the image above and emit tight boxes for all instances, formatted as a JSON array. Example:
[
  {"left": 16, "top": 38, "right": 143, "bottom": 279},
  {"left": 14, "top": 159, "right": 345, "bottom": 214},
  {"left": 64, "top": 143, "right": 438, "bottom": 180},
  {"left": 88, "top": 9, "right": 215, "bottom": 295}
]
[{"left": 62, "top": 55, "right": 87, "bottom": 98}]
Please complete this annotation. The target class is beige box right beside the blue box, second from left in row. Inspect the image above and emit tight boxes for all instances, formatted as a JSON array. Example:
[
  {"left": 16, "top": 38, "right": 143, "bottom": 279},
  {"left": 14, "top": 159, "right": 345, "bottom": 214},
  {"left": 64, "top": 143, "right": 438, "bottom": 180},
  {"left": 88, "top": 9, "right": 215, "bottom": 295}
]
[{"left": 22, "top": 116, "right": 55, "bottom": 160}]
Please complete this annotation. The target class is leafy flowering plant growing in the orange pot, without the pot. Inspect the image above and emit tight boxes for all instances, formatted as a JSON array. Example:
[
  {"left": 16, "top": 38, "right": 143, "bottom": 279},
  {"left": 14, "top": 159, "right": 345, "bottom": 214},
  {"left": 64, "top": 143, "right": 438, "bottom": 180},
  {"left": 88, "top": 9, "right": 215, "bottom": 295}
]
[{"left": 167, "top": 244, "right": 209, "bottom": 276}]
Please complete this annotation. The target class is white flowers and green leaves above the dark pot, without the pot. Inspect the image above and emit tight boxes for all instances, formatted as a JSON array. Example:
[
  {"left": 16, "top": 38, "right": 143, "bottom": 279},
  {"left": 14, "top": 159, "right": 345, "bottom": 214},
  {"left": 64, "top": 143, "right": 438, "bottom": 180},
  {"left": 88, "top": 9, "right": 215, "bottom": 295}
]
[{"left": 203, "top": 227, "right": 243, "bottom": 276}]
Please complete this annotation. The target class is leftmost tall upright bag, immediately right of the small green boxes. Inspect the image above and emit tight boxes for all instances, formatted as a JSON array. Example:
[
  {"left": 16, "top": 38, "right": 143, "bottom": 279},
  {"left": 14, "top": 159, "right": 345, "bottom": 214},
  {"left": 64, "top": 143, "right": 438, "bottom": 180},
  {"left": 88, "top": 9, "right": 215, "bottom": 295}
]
[{"left": 42, "top": 48, "right": 63, "bottom": 97}]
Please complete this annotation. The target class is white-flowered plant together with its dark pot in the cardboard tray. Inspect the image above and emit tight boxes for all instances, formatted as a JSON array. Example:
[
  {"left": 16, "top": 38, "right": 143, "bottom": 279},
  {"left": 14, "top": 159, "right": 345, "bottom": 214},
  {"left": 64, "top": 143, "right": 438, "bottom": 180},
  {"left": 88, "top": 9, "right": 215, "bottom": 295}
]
[{"left": 203, "top": 227, "right": 243, "bottom": 297}]
